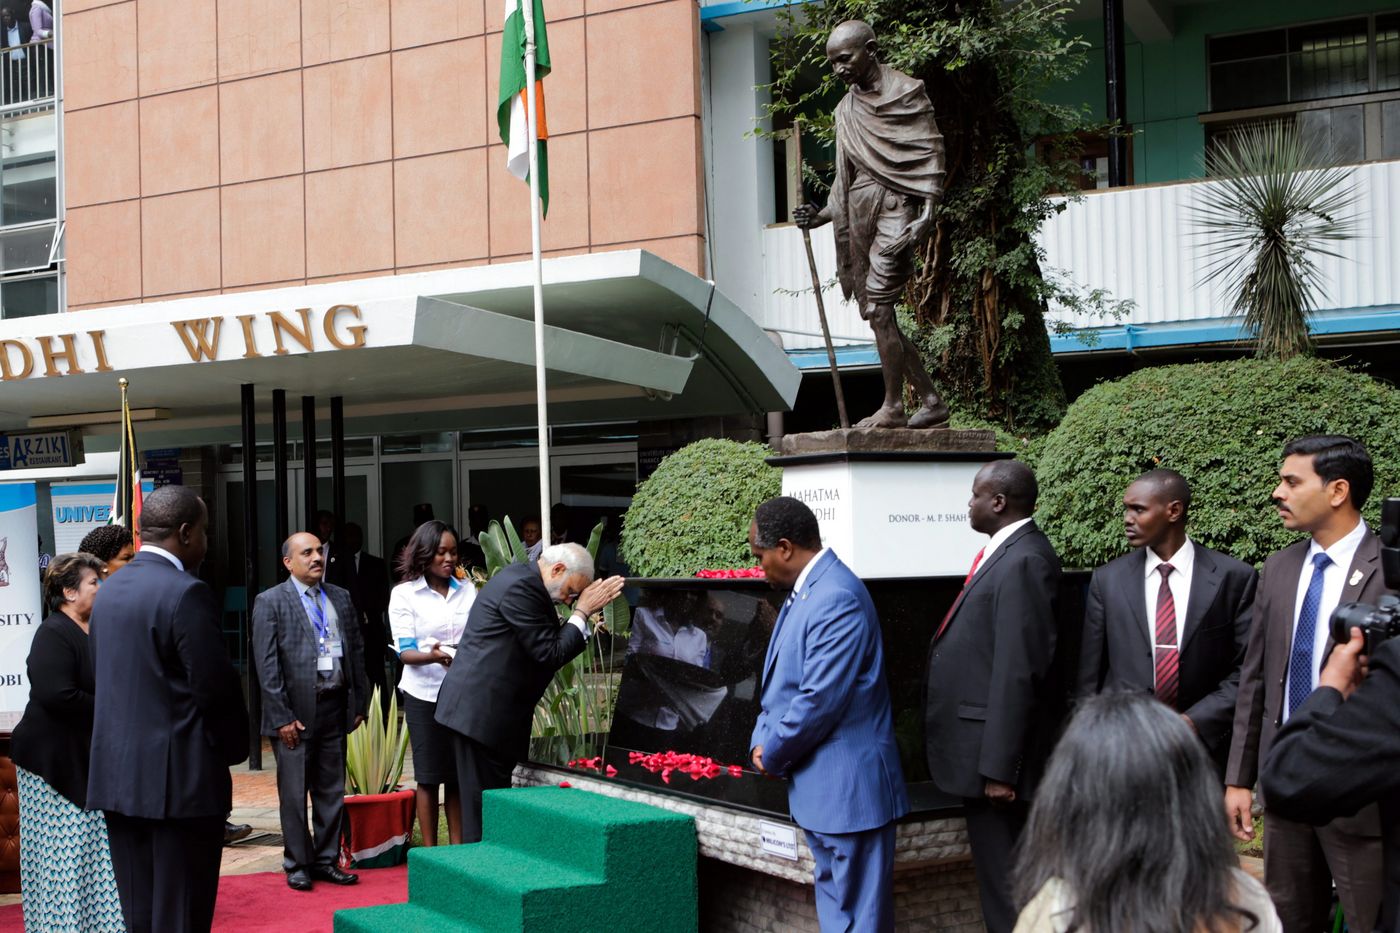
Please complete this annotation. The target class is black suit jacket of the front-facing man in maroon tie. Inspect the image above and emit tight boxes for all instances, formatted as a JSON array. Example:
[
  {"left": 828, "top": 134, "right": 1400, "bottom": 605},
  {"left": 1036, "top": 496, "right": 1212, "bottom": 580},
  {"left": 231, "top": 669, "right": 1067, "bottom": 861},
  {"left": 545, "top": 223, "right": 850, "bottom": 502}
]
[{"left": 1075, "top": 542, "right": 1259, "bottom": 768}]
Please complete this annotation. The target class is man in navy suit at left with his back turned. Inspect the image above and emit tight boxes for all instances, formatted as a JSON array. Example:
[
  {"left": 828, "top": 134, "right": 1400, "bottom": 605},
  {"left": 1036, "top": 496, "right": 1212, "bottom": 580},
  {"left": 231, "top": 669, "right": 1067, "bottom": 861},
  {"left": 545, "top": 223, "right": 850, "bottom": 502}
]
[{"left": 87, "top": 486, "right": 248, "bottom": 933}]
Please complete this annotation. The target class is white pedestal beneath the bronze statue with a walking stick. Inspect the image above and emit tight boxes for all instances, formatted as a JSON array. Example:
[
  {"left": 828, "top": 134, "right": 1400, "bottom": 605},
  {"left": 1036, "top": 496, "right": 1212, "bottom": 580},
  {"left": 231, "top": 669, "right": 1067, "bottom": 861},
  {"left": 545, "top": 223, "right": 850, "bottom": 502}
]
[{"left": 769, "top": 427, "right": 1011, "bottom": 580}]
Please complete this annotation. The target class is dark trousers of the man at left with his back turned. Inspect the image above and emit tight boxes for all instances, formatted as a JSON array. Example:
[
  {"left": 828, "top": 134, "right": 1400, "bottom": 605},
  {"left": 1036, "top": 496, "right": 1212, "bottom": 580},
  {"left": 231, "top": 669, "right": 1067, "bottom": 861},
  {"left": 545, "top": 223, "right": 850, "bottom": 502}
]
[{"left": 106, "top": 811, "right": 224, "bottom": 933}]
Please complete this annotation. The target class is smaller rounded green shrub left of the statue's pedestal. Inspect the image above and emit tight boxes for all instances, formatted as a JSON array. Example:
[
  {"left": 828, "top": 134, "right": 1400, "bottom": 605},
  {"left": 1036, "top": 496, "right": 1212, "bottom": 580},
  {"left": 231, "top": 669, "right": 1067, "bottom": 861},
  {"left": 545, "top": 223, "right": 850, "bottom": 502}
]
[{"left": 622, "top": 438, "right": 783, "bottom": 577}]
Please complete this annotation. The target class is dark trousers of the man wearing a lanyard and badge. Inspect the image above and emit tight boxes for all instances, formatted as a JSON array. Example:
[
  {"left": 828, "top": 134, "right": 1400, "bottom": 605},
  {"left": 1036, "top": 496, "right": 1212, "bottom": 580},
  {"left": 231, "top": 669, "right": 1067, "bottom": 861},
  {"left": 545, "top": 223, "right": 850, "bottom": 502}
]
[{"left": 272, "top": 686, "right": 350, "bottom": 871}]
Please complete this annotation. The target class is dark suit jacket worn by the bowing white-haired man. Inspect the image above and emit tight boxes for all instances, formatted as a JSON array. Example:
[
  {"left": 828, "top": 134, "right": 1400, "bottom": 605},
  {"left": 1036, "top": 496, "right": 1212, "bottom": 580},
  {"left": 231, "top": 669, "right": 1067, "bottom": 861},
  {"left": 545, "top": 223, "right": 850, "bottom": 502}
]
[{"left": 437, "top": 560, "right": 584, "bottom": 761}]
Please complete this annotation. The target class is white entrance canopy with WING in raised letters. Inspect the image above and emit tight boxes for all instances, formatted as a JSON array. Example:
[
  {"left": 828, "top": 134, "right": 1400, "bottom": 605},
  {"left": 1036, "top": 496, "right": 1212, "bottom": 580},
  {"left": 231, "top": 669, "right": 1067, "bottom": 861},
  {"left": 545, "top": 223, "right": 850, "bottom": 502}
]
[{"left": 0, "top": 249, "right": 799, "bottom": 450}]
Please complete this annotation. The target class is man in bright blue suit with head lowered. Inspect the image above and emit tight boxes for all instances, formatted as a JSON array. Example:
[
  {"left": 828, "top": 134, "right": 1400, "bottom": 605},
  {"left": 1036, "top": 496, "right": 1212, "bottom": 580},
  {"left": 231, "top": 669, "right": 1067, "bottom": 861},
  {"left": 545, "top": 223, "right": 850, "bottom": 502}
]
[{"left": 749, "top": 496, "right": 909, "bottom": 933}]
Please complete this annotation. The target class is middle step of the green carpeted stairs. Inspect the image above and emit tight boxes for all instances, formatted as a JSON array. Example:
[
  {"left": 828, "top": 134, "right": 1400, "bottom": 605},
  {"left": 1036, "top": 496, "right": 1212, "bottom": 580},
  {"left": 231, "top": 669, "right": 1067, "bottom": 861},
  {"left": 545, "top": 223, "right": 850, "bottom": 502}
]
[{"left": 409, "top": 842, "right": 605, "bottom": 930}]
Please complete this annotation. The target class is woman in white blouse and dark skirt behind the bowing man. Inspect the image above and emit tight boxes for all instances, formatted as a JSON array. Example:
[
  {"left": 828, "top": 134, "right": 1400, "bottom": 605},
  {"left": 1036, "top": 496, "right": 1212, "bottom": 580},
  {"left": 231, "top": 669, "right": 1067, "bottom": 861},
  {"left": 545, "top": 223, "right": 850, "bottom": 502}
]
[{"left": 389, "top": 521, "right": 476, "bottom": 846}]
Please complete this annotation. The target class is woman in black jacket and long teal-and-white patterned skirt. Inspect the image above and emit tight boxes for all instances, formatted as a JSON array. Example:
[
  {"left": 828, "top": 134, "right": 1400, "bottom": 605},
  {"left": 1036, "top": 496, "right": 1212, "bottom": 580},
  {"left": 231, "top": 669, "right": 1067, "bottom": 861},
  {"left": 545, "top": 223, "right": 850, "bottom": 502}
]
[{"left": 11, "top": 553, "right": 125, "bottom": 933}]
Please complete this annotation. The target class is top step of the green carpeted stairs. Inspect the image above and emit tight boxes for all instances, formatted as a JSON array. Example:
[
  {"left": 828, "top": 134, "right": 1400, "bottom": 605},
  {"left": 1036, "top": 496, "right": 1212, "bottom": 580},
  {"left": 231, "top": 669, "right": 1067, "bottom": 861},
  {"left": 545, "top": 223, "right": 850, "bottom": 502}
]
[{"left": 482, "top": 787, "right": 696, "bottom": 894}]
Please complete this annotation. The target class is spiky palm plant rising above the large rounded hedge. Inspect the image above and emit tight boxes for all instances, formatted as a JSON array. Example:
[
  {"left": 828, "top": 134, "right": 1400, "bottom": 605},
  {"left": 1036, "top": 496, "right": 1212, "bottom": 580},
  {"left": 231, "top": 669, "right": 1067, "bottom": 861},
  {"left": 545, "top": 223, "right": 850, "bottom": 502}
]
[{"left": 1191, "top": 123, "right": 1358, "bottom": 360}]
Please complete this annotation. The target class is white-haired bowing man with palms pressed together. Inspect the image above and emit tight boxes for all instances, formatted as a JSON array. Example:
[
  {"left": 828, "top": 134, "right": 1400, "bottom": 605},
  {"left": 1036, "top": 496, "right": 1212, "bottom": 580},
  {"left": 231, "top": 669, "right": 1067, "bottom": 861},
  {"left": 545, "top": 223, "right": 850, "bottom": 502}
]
[{"left": 435, "top": 544, "right": 623, "bottom": 842}]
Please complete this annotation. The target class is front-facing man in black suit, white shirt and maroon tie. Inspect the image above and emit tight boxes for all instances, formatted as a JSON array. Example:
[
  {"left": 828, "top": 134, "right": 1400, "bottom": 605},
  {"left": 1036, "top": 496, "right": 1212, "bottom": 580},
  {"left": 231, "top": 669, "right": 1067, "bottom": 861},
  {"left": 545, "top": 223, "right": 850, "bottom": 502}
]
[{"left": 1077, "top": 469, "right": 1259, "bottom": 775}]
